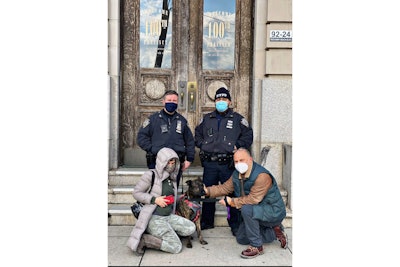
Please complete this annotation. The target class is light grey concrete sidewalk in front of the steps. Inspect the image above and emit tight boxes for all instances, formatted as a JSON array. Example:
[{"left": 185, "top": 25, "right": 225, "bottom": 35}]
[{"left": 108, "top": 226, "right": 292, "bottom": 266}]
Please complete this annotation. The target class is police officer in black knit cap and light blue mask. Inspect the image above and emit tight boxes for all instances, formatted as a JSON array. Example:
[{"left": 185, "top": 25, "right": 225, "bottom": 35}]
[{"left": 195, "top": 87, "right": 253, "bottom": 235}]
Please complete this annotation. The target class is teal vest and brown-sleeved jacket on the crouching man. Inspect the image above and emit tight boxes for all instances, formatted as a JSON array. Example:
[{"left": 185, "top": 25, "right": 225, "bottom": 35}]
[{"left": 209, "top": 161, "right": 286, "bottom": 222}]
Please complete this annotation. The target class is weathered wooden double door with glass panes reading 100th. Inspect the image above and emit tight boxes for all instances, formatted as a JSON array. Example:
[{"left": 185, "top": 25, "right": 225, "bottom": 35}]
[{"left": 118, "top": 0, "right": 253, "bottom": 167}]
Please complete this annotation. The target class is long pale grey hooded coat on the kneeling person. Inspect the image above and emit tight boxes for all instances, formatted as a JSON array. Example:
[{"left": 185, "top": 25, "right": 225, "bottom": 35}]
[{"left": 127, "top": 148, "right": 179, "bottom": 251}]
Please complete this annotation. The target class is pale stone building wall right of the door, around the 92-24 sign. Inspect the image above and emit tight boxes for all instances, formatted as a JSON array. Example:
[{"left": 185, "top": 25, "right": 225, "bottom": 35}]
[{"left": 252, "top": 0, "right": 292, "bottom": 196}]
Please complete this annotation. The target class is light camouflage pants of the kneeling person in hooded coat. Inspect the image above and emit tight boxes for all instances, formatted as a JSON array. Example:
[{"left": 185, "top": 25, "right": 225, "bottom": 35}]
[{"left": 146, "top": 214, "right": 196, "bottom": 253}]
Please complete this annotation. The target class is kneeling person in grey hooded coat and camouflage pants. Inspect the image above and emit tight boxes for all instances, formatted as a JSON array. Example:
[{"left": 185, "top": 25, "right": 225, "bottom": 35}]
[{"left": 127, "top": 148, "right": 196, "bottom": 255}]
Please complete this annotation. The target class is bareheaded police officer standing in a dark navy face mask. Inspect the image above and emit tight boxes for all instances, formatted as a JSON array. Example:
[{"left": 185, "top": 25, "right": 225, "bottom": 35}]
[{"left": 137, "top": 90, "right": 195, "bottom": 186}]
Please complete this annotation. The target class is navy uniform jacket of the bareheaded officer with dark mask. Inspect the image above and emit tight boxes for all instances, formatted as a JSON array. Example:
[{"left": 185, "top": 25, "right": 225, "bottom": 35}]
[{"left": 137, "top": 110, "right": 195, "bottom": 162}]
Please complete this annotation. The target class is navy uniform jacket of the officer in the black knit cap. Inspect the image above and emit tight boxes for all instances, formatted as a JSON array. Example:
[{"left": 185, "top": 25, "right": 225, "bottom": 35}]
[{"left": 195, "top": 109, "right": 253, "bottom": 153}]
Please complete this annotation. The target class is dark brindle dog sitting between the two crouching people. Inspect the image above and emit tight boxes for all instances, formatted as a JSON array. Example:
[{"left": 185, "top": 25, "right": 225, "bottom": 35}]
[{"left": 176, "top": 177, "right": 208, "bottom": 248}]
